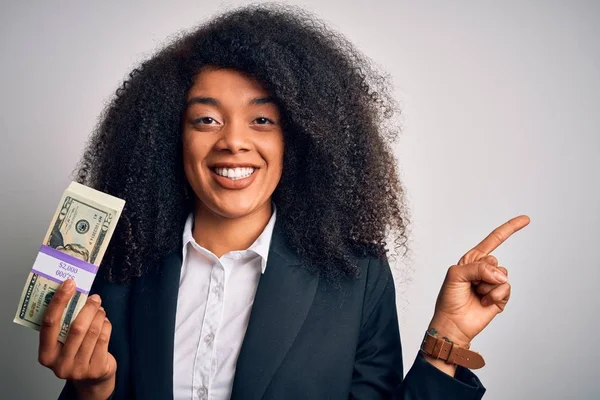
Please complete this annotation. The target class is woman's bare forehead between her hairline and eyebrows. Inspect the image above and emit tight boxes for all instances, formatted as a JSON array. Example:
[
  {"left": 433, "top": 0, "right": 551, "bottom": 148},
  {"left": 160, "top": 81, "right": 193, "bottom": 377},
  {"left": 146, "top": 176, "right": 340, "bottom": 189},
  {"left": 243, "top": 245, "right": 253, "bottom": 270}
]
[{"left": 188, "top": 67, "right": 269, "bottom": 98}]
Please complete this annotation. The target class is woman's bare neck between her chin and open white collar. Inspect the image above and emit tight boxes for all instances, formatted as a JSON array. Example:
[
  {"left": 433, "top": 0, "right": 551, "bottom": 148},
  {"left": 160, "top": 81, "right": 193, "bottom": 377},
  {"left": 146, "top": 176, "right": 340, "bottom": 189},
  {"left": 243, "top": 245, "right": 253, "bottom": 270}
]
[{"left": 192, "top": 200, "right": 271, "bottom": 257}]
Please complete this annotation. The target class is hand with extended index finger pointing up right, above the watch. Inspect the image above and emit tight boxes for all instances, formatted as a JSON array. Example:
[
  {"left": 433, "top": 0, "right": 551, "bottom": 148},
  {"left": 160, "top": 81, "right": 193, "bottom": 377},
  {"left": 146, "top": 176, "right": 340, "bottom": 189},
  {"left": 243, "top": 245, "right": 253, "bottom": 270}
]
[{"left": 429, "top": 215, "right": 529, "bottom": 345}]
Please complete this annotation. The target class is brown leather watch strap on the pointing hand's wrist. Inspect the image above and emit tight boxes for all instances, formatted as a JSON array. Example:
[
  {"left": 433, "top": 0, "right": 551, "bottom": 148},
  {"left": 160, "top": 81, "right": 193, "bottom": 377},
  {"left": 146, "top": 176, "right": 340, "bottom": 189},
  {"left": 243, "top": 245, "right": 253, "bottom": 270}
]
[{"left": 421, "top": 332, "right": 485, "bottom": 369}]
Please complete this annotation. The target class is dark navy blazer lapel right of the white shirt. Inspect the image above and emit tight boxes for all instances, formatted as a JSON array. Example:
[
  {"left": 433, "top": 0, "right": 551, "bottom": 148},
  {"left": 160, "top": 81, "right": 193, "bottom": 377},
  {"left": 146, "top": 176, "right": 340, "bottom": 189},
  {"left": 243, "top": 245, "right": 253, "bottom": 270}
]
[{"left": 231, "top": 221, "right": 319, "bottom": 400}]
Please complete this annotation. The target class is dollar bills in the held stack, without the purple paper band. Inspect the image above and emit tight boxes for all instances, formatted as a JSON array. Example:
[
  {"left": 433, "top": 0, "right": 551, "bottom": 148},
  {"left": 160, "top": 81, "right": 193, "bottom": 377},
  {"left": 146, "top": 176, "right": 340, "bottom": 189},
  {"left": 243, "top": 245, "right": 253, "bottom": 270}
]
[{"left": 14, "top": 182, "right": 125, "bottom": 343}]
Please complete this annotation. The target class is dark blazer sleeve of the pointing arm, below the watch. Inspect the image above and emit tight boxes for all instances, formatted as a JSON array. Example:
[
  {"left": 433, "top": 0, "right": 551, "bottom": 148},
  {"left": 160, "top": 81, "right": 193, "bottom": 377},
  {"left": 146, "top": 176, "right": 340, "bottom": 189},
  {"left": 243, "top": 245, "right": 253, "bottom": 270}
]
[{"left": 349, "top": 258, "right": 485, "bottom": 400}]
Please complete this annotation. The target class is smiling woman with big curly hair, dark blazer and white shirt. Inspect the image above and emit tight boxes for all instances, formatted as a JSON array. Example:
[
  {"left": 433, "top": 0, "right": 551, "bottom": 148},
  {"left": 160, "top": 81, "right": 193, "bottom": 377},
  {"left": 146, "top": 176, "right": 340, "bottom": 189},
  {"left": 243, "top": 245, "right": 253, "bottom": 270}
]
[{"left": 39, "top": 5, "right": 528, "bottom": 399}]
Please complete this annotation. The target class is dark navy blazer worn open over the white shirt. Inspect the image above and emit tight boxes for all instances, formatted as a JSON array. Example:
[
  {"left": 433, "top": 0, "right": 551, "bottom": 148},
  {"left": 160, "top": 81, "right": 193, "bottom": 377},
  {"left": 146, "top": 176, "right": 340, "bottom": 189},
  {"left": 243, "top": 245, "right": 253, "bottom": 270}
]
[{"left": 60, "top": 222, "right": 485, "bottom": 400}]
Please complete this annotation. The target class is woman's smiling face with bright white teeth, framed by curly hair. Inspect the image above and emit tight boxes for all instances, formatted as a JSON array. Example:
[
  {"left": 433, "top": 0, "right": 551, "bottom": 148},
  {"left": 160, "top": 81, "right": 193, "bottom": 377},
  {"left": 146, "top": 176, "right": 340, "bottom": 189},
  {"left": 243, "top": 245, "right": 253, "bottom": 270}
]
[{"left": 183, "top": 68, "right": 284, "bottom": 218}]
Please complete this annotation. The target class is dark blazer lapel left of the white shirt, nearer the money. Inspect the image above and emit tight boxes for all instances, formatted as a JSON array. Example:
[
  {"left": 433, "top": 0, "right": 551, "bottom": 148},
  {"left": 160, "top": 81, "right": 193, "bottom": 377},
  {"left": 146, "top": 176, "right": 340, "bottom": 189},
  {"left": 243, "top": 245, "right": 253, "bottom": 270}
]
[{"left": 131, "top": 252, "right": 182, "bottom": 399}]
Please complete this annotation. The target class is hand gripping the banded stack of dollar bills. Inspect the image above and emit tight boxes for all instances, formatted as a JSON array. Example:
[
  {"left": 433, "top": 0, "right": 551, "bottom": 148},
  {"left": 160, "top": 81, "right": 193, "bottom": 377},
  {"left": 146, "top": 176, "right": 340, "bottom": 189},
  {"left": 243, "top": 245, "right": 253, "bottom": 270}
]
[{"left": 38, "top": 279, "right": 117, "bottom": 400}]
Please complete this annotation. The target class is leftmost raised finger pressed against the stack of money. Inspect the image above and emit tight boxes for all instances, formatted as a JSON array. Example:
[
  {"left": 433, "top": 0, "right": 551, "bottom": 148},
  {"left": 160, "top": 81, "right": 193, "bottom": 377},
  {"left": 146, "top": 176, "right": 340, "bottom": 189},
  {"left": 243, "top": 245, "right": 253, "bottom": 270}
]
[{"left": 39, "top": 279, "right": 75, "bottom": 358}]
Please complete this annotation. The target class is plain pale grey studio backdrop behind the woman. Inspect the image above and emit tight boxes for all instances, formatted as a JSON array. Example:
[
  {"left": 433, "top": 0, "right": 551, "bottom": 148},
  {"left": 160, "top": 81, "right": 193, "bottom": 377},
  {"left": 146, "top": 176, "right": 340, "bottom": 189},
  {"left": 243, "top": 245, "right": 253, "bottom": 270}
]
[{"left": 0, "top": 0, "right": 600, "bottom": 399}]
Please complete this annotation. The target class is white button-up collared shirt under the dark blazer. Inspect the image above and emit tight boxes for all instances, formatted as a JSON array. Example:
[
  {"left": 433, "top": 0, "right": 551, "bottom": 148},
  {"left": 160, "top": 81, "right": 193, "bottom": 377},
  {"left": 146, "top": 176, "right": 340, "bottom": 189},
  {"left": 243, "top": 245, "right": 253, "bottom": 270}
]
[{"left": 173, "top": 204, "right": 277, "bottom": 400}]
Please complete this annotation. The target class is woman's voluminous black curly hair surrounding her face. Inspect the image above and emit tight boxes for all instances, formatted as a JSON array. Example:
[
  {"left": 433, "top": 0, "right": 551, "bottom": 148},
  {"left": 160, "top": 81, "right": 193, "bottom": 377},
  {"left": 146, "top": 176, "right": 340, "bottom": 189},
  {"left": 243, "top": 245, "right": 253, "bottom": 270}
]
[{"left": 75, "top": 4, "right": 408, "bottom": 281}]
